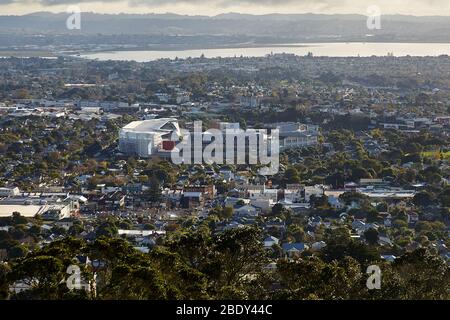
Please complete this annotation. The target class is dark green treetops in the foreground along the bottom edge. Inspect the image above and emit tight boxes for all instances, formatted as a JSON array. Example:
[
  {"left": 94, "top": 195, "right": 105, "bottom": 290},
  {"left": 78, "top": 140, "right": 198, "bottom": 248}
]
[{"left": 4, "top": 225, "right": 450, "bottom": 300}]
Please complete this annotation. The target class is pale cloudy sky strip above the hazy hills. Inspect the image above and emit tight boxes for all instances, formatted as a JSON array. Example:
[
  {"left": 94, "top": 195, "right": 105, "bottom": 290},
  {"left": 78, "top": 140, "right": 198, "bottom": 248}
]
[{"left": 0, "top": 0, "right": 450, "bottom": 16}]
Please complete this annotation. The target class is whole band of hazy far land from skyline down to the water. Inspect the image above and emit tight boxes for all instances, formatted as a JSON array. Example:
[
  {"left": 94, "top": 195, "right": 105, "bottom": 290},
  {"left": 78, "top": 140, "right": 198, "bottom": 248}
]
[{"left": 0, "top": 12, "right": 450, "bottom": 49}]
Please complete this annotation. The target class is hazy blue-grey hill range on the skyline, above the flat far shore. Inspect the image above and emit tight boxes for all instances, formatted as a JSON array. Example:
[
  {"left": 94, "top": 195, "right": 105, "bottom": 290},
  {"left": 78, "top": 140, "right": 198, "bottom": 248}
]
[{"left": 0, "top": 12, "right": 450, "bottom": 41}]
